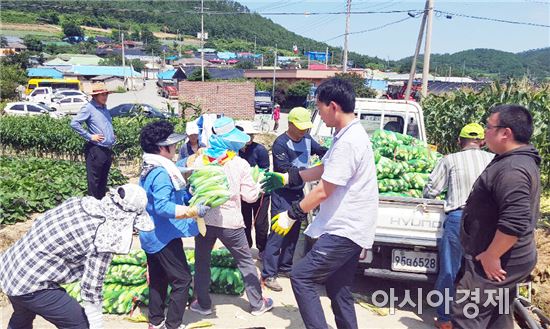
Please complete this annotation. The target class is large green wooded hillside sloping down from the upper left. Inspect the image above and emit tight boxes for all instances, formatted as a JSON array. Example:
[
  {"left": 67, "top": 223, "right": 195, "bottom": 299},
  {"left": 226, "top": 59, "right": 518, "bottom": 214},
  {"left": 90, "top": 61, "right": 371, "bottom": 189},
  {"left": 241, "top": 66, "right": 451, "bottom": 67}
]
[{"left": 0, "top": 0, "right": 385, "bottom": 66}]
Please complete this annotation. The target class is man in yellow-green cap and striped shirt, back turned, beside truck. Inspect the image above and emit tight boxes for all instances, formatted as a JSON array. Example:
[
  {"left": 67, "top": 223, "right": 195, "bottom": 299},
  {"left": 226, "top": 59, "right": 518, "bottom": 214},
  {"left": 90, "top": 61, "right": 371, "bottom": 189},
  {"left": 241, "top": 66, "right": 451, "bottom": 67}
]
[{"left": 424, "top": 123, "right": 494, "bottom": 329}]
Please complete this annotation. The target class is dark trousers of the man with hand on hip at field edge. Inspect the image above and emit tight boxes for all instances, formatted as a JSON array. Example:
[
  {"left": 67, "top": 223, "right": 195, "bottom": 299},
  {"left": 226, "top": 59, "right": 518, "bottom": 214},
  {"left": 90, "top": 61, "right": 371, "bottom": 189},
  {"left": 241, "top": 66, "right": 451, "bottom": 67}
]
[{"left": 84, "top": 143, "right": 113, "bottom": 199}]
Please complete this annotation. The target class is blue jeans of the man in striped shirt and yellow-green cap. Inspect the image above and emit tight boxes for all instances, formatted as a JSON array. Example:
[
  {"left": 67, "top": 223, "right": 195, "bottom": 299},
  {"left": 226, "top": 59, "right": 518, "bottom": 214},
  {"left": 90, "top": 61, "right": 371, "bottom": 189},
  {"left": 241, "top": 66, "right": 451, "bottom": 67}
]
[{"left": 435, "top": 209, "right": 463, "bottom": 322}]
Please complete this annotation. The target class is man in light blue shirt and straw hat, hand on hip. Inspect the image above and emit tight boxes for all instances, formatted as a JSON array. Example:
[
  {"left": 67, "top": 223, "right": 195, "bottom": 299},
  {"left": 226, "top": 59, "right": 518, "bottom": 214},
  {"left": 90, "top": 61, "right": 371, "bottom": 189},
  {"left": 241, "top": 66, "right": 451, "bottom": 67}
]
[{"left": 71, "top": 84, "right": 116, "bottom": 199}]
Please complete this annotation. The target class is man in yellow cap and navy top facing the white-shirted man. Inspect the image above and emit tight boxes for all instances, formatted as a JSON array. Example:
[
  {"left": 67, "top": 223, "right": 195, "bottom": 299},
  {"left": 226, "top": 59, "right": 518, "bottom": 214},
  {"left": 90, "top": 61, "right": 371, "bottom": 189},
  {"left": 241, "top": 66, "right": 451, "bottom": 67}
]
[{"left": 262, "top": 107, "right": 327, "bottom": 291}]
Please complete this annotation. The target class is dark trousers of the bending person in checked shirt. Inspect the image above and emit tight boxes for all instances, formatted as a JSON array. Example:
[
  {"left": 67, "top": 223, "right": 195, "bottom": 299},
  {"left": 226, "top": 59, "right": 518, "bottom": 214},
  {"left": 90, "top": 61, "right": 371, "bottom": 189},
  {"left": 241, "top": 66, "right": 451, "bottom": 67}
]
[{"left": 8, "top": 288, "right": 89, "bottom": 329}]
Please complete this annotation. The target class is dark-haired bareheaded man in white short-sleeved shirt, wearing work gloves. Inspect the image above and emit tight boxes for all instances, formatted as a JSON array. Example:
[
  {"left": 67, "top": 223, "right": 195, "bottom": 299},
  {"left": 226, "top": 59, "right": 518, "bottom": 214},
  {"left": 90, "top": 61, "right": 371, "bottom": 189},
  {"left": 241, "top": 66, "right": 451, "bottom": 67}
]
[{"left": 264, "top": 78, "right": 378, "bottom": 328}]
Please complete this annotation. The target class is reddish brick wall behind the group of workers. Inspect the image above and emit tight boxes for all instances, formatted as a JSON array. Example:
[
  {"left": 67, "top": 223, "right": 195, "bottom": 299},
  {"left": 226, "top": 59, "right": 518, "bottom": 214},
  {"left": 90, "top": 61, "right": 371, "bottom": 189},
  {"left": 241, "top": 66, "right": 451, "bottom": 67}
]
[{"left": 179, "top": 81, "right": 255, "bottom": 120}]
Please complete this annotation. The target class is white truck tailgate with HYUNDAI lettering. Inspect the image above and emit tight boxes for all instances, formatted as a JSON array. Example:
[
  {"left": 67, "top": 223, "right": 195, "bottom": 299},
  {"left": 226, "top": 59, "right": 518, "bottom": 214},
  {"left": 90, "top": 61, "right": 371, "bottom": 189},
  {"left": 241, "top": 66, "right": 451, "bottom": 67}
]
[{"left": 374, "top": 197, "right": 445, "bottom": 247}]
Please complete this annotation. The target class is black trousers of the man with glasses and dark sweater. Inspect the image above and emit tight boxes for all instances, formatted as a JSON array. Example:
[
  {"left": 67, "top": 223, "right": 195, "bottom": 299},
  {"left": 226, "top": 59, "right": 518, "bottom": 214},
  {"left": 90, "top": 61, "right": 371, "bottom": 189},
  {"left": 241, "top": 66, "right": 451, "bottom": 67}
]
[{"left": 451, "top": 255, "right": 537, "bottom": 329}]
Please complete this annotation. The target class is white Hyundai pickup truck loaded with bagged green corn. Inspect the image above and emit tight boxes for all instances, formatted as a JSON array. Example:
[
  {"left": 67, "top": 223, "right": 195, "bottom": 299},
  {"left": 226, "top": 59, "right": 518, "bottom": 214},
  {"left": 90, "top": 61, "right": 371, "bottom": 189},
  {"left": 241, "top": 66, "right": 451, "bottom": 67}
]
[{"left": 306, "top": 98, "right": 445, "bottom": 281}]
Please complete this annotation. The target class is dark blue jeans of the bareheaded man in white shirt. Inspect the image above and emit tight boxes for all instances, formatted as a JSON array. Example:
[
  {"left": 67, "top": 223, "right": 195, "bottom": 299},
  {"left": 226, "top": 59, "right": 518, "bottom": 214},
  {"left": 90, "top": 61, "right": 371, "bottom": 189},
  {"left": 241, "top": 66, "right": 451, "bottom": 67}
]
[{"left": 290, "top": 234, "right": 362, "bottom": 329}]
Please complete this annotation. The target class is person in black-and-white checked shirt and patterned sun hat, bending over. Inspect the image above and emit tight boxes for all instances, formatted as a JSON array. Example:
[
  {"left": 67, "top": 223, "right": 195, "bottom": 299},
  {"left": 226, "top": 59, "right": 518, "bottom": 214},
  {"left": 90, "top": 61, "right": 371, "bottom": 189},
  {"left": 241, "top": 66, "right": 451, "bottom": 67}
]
[{"left": 0, "top": 184, "right": 154, "bottom": 329}]
